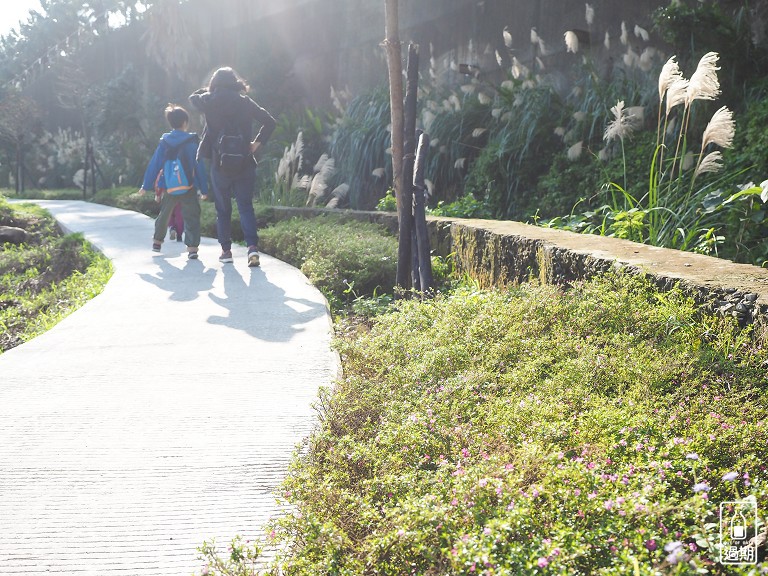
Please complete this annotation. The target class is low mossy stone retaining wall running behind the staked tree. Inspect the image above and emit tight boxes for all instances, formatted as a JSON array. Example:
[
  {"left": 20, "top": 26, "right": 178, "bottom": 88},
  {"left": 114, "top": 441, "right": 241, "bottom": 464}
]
[{"left": 266, "top": 208, "right": 768, "bottom": 325}]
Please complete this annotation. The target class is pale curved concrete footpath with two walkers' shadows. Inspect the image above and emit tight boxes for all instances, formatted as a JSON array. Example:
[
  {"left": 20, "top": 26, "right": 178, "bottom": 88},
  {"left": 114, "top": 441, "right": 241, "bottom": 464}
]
[{"left": 0, "top": 201, "right": 338, "bottom": 576}]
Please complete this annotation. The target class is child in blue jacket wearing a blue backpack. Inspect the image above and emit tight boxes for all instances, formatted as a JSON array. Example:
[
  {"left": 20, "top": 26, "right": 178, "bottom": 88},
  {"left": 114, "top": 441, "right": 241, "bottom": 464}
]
[{"left": 139, "top": 104, "right": 208, "bottom": 260}]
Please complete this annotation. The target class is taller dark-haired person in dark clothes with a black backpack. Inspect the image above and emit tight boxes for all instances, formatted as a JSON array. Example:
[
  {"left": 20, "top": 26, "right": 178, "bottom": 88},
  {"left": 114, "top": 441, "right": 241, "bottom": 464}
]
[{"left": 189, "top": 68, "right": 276, "bottom": 266}]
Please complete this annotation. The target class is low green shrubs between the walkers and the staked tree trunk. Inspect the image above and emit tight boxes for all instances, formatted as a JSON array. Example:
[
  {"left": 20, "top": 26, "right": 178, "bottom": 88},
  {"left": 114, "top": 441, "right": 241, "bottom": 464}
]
[{"left": 259, "top": 216, "right": 397, "bottom": 310}]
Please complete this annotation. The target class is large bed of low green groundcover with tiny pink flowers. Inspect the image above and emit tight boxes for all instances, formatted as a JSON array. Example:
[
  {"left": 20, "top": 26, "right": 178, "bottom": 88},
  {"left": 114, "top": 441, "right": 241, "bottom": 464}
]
[{"left": 198, "top": 274, "right": 768, "bottom": 575}]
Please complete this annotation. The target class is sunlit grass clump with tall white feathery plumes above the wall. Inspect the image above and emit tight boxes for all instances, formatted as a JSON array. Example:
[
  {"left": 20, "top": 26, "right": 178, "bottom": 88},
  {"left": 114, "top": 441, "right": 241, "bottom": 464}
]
[{"left": 542, "top": 53, "right": 765, "bottom": 263}]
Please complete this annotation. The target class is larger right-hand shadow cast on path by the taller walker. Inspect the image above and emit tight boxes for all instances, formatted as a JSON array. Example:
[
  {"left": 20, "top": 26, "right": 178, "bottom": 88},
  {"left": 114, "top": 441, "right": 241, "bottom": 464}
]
[{"left": 208, "top": 266, "right": 326, "bottom": 342}]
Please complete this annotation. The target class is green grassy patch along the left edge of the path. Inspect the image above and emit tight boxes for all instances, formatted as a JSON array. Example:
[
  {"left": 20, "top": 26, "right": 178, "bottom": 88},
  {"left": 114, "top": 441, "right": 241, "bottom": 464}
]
[{"left": 0, "top": 199, "right": 112, "bottom": 353}]
